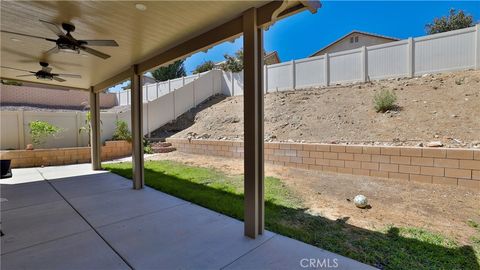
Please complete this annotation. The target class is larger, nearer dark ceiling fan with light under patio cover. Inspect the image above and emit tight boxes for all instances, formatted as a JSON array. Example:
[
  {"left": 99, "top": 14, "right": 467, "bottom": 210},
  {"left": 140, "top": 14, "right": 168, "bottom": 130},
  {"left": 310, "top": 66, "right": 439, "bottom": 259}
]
[{"left": 1, "top": 20, "right": 118, "bottom": 59}]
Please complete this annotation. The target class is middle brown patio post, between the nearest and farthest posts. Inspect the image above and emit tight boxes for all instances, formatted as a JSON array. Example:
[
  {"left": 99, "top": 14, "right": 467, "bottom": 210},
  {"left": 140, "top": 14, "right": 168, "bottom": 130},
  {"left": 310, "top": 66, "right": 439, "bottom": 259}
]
[{"left": 130, "top": 65, "right": 144, "bottom": 189}]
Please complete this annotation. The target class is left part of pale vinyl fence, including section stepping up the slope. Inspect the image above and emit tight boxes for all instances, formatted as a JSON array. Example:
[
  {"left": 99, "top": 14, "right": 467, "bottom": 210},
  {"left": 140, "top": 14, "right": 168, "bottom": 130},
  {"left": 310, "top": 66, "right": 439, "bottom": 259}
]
[{"left": 0, "top": 70, "right": 222, "bottom": 150}]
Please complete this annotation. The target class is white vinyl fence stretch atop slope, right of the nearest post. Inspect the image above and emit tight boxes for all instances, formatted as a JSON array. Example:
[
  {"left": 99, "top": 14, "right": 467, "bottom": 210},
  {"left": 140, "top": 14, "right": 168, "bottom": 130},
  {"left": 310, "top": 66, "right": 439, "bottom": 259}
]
[{"left": 262, "top": 25, "right": 480, "bottom": 92}]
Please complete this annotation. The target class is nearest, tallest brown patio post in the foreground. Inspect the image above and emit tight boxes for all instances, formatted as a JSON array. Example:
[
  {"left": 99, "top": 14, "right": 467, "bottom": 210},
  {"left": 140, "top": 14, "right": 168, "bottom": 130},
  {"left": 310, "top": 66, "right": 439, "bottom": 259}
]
[{"left": 243, "top": 8, "right": 264, "bottom": 238}]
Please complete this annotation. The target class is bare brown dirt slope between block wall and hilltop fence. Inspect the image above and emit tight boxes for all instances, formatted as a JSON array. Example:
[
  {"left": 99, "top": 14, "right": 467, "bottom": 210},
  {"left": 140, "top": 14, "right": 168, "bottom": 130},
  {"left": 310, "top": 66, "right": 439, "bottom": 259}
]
[{"left": 154, "top": 71, "right": 480, "bottom": 147}]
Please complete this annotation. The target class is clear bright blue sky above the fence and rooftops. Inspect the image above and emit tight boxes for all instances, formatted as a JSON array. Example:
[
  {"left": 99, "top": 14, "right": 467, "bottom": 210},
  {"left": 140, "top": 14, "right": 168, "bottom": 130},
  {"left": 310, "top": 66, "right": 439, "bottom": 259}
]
[{"left": 109, "top": 1, "right": 480, "bottom": 92}]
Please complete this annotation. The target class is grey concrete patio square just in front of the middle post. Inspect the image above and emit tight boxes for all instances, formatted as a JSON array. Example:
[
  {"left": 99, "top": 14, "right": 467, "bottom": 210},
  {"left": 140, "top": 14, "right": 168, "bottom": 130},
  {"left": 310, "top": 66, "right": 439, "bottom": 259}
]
[{"left": 70, "top": 186, "right": 186, "bottom": 227}]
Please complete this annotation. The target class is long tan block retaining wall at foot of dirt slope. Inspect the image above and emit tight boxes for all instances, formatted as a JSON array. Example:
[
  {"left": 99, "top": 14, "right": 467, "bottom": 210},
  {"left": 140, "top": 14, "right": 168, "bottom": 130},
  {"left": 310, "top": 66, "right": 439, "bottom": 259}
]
[{"left": 167, "top": 138, "right": 480, "bottom": 190}]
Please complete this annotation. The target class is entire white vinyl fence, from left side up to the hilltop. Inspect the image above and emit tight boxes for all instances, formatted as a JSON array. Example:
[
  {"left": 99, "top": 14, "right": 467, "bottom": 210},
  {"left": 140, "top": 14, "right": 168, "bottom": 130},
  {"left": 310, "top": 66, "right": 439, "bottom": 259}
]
[{"left": 0, "top": 25, "right": 480, "bottom": 149}]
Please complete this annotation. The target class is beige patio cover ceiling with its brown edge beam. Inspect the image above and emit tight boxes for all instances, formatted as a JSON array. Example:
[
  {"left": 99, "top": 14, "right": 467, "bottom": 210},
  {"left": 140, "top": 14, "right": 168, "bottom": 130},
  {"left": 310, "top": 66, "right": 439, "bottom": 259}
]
[{"left": 1, "top": 1, "right": 320, "bottom": 91}]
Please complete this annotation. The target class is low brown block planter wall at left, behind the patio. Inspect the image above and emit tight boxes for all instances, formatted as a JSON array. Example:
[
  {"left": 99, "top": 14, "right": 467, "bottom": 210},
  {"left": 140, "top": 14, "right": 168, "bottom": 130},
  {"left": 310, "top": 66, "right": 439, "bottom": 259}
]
[{"left": 0, "top": 141, "right": 132, "bottom": 168}]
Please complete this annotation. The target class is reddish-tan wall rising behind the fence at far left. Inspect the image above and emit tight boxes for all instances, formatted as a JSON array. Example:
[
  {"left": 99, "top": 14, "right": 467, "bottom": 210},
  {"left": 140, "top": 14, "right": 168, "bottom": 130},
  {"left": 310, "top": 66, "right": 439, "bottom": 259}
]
[{"left": 0, "top": 84, "right": 117, "bottom": 109}]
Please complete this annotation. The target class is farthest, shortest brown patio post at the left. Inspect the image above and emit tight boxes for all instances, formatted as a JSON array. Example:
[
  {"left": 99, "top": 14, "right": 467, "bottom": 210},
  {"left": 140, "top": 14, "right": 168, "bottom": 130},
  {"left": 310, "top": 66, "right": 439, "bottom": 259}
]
[{"left": 90, "top": 87, "right": 102, "bottom": 170}]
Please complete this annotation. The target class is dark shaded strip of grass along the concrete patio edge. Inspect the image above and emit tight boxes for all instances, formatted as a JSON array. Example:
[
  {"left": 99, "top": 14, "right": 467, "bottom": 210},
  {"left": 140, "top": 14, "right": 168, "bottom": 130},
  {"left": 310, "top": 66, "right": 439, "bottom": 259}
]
[{"left": 106, "top": 165, "right": 480, "bottom": 269}]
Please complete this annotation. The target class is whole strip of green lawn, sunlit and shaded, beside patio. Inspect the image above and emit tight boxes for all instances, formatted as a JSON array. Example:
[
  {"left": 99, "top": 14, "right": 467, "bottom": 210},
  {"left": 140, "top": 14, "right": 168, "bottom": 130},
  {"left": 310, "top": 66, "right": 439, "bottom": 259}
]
[{"left": 103, "top": 161, "right": 480, "bottom": 269}]
